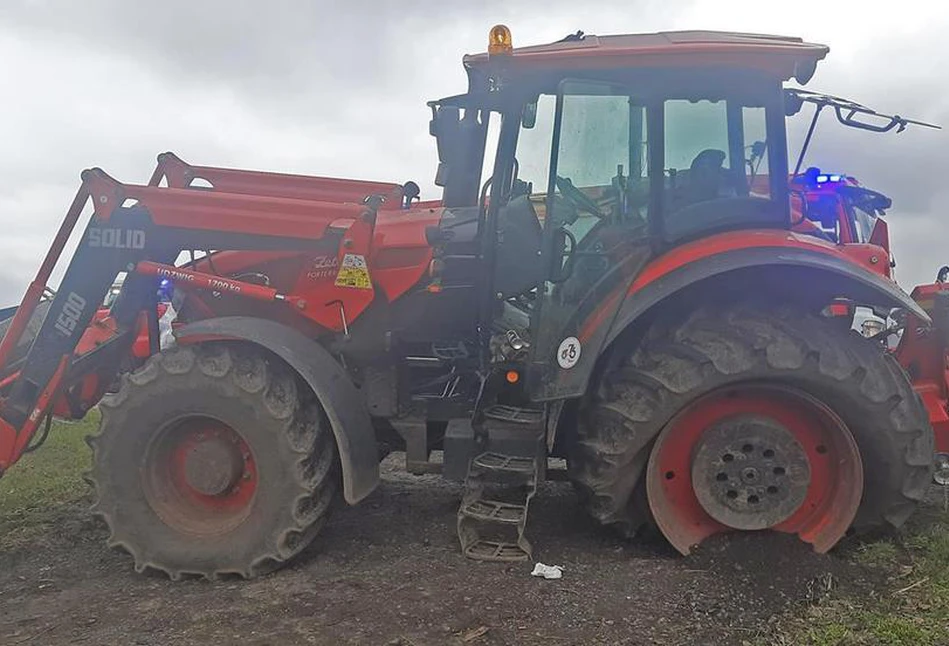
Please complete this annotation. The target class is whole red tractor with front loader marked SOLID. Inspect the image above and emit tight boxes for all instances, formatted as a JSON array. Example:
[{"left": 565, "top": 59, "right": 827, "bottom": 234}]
[{"left": 0, "top": 26, "right": 949, "bottom": 578}]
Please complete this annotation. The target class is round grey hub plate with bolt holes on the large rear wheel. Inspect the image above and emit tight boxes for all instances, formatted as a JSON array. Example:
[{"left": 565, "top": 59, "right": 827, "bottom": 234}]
[{"left": 692, "top": 415, "right": 811, "bottom": 530}]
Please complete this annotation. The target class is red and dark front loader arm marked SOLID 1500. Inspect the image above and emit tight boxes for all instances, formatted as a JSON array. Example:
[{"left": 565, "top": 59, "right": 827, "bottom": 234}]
[{"left": 0, "top": 159, "right": 392, "bottom": 474}]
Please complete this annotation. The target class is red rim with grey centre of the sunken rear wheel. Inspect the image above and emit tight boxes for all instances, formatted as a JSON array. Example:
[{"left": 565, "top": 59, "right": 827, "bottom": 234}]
[{"left": 646, "top": 383, "right": 863, "bottom": 554}]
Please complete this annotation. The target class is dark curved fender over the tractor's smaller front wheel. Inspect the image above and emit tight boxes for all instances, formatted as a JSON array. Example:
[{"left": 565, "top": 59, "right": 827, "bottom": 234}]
[{"left": 176, "top": 316, "right": 379, "bottom": 505}]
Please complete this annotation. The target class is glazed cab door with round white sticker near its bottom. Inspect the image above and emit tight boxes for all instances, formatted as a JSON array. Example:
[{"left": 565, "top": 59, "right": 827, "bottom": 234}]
[{"left": 518, "top": 81, "right": 661, "bottom": 401}]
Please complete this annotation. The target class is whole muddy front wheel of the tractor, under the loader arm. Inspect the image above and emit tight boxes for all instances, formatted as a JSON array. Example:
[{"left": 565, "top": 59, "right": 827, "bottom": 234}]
[{"left": 87, "top": 343, "right": 340, "bottom": 580}]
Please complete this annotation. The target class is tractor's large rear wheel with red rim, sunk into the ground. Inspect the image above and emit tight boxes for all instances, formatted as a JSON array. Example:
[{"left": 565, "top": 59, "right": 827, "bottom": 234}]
[{"left": 570, "top": 306, "right": 933, "bottom": 554}]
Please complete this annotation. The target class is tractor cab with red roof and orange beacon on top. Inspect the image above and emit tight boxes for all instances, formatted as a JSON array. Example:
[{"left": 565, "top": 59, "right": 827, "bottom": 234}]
[{"left": 431, "top": 26, "right": 827, "bottom": 401}]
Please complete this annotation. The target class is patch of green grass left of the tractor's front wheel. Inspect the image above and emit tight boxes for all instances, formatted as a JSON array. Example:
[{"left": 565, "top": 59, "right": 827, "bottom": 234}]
[{"left": 0, "top": 409, "right": 99, "bottom": 549}]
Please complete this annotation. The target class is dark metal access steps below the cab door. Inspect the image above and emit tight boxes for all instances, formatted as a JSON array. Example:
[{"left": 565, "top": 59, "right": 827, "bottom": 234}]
[{"left": 458, "top": 406, "right": 547, "bottom": 562}]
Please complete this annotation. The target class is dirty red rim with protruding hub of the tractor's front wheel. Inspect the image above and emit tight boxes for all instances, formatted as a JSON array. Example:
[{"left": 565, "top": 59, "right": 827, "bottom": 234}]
[{"left": 142, "top": 416, "right": 258, "bottom": 535}]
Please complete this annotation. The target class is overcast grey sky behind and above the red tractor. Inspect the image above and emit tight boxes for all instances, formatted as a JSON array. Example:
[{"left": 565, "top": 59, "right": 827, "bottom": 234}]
[{"left": 0, "top": 0, "right": 949, "bottom": 306}]
